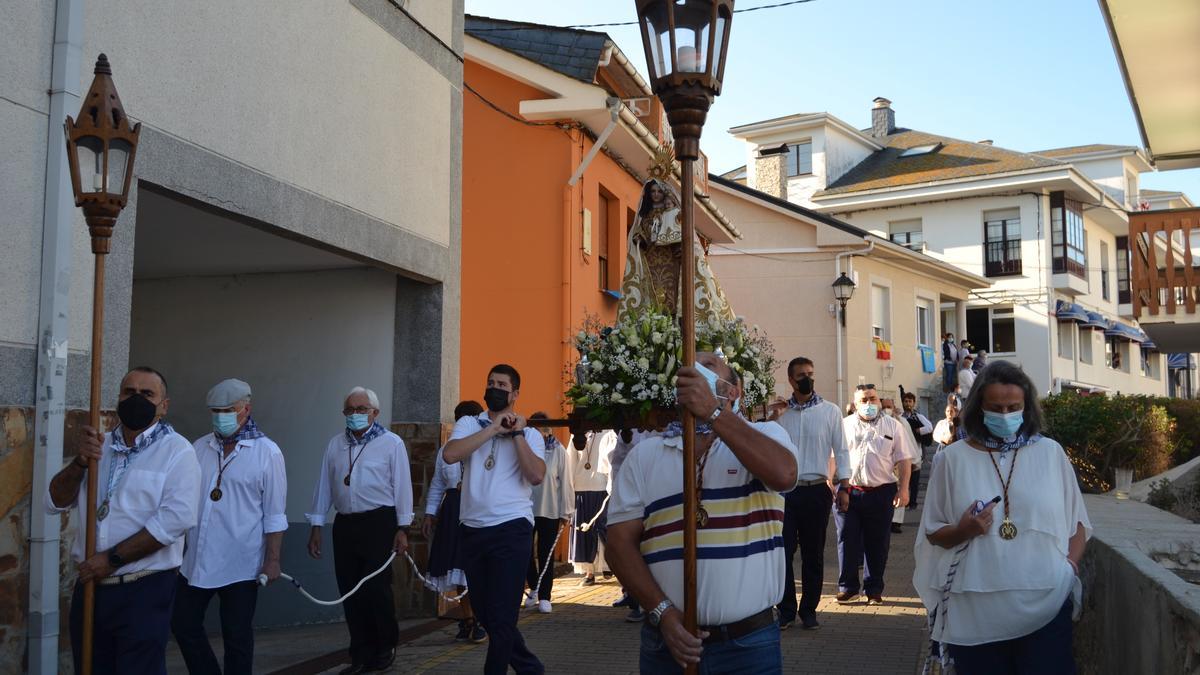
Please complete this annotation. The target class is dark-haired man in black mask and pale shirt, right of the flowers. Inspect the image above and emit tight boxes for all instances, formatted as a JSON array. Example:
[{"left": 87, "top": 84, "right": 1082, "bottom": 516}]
[{"left": 776, "top": 357, "right": 850, "bottom": 631}]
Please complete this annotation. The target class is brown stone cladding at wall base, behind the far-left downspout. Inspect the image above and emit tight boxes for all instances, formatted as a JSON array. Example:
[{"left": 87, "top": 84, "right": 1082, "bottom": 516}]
[{"left": 0, "top": 407, "right": 112, "bottom": 671}]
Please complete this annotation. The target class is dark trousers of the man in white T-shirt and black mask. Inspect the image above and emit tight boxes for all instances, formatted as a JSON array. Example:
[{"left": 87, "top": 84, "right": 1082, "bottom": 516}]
[{"left": 460, "top": 518, "right": 546, "bottom": 675}]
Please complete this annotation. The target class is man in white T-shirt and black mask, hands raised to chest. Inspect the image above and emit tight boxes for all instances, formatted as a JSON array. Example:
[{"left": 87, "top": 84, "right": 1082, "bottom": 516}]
[{"left": 442, "top": 364, "right": 546, "bottom": 675}]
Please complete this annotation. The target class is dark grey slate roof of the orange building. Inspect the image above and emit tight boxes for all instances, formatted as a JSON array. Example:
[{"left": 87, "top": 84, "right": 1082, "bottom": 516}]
[{"left": 464, "top": 14, "right": 608, "bottom": 84}]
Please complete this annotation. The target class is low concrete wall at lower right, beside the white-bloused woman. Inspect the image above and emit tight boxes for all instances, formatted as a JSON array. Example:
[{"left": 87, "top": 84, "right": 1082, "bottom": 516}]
[{"left": 1075, "top": 495, "right": 1200, "bottom": 675}]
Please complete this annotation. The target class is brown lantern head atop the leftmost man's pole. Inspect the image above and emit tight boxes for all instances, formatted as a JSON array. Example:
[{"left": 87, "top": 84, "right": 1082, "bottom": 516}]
[{"left": 64, "top": 54, "right": 142, "bottom": 253}]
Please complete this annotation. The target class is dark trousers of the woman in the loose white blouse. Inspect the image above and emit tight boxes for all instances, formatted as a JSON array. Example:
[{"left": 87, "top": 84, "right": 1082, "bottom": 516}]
[{"left": 947, "top": 597, "right": 1075, "bottom": 675}]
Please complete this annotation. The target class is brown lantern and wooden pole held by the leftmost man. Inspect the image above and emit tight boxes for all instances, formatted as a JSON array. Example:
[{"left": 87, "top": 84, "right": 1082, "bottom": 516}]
[{"left": 64, "top": 54, "right": 142, "bottom": 675}]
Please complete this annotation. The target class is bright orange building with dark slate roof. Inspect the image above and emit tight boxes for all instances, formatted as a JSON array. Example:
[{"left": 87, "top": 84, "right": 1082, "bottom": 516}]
[{"left": 460, "top": 17, "right": 731, "bottom": 417}]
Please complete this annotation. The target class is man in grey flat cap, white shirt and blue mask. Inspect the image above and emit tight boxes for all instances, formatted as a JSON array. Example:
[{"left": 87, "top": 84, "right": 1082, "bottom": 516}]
[{"left": 170, "top": 380, "right": 288, "bottom": 675}]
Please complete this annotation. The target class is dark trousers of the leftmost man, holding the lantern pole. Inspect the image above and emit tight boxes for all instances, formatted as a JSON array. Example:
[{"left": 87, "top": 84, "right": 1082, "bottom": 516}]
[{"left": 71, "top": 569, "right": 176, "bottom": 675}]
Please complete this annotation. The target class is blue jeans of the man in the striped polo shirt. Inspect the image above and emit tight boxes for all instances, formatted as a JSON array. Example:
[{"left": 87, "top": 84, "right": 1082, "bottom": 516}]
[{"left": 638, "top": 622, "right": 784, "bottom": 675}]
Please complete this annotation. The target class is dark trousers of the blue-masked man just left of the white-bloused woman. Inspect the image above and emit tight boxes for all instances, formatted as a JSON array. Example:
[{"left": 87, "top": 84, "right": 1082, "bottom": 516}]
[{"left": 833, "top": 483, "right": 896, "bottom": 596}]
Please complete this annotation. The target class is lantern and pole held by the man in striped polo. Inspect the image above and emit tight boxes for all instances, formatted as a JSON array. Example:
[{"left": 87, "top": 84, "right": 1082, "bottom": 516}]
[{"left": 637, "top": 0, "right": 733, "bottom": 673}]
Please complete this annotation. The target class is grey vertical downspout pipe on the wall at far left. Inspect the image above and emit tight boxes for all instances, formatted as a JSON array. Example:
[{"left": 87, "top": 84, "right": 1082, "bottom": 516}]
[{"left": 28, "top": 0, "right": 84, "bottom": 675}]
